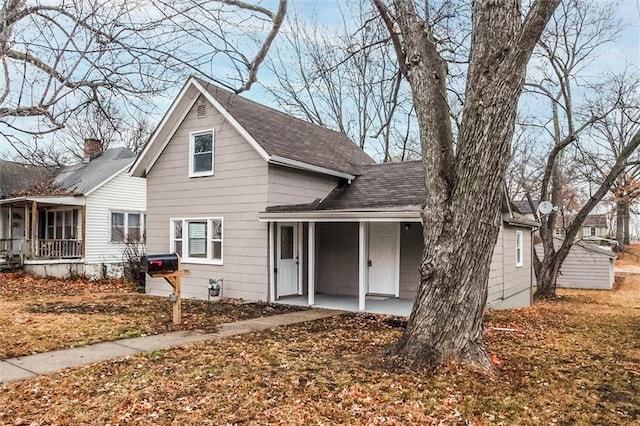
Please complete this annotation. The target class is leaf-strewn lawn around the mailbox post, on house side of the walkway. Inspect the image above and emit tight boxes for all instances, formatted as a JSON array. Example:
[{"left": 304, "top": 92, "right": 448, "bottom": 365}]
[{"left": 0, "top": 273, "right": 304, "bottom": 359}]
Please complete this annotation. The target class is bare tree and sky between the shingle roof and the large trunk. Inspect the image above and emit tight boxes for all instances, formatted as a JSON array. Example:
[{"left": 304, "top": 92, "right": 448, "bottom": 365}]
[{"left": 265, "top": 0, "right": 419, "bottom": 162}]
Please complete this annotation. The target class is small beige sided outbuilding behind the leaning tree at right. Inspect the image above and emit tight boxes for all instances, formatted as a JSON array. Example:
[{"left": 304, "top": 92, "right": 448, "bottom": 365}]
[{"left": 536, "top": 240, "right": 618, "bottom": 290}]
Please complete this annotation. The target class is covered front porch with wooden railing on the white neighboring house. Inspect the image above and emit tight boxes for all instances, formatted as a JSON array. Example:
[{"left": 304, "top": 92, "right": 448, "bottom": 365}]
[{"left": 0, "top": 196, "right": 84, "bottom": 264}]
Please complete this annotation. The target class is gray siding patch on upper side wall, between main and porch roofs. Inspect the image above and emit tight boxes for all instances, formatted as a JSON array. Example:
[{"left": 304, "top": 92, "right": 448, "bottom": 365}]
[{"left": 268, "top": 165, "right": 338, "bottom": 206}]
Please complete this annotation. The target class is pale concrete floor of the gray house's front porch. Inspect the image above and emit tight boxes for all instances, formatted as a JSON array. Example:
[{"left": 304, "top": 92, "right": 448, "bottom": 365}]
[{"left": 276, "top": 294, "right": 413, "bottom": 317}]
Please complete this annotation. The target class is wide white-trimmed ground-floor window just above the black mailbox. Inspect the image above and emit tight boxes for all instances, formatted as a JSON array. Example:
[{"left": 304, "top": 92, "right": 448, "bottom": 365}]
[{"left": 170, "top": 217, "right": 223, "bottom": 265}]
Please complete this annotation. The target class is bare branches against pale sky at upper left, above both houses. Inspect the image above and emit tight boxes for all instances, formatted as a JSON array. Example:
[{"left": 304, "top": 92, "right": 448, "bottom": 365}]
[{"left": 0, "top": 0, "right": 287, "bottom": 156}]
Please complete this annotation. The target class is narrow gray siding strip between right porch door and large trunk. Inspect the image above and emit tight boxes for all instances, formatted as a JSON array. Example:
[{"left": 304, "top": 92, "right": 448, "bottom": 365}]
[{"left": 400, "top": 223, "right": 424, "bottom": 299}]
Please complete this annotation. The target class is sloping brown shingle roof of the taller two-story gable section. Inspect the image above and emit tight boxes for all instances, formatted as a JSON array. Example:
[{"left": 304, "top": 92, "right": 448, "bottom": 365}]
[{"left": 196, "top": 78, "right": 374, "bottom": 174}]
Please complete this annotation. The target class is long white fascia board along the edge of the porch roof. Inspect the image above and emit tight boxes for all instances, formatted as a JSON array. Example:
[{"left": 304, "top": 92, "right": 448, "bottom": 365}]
[{"left": 258, "top": 206, "right": 421, "bottom": 222}]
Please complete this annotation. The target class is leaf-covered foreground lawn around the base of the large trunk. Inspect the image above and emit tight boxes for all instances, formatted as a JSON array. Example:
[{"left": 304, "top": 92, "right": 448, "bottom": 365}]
[{"left": 0, "top": 276, "right": 640, "bottom": 425}]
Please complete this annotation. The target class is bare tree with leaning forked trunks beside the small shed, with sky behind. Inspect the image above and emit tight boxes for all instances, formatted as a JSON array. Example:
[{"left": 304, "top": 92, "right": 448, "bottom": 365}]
[{"left": 508, "top": 0, "right": 640, "bottom": 297}]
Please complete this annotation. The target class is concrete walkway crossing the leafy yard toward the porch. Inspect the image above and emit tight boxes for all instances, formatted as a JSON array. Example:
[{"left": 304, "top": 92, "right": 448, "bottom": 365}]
[{"left": 0, "top": 309, "right": 343, "bottom": 383}]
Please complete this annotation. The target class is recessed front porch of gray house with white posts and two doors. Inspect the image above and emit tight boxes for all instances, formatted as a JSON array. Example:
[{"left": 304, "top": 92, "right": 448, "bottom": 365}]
[{"left": 261, "top": 212, "right": 423, "bottom": 316}]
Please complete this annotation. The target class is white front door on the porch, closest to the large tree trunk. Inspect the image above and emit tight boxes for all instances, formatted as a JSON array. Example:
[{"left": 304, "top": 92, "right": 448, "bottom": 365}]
[{"left": 368, "top": 222, "right": 400, "bottom": 296}]
